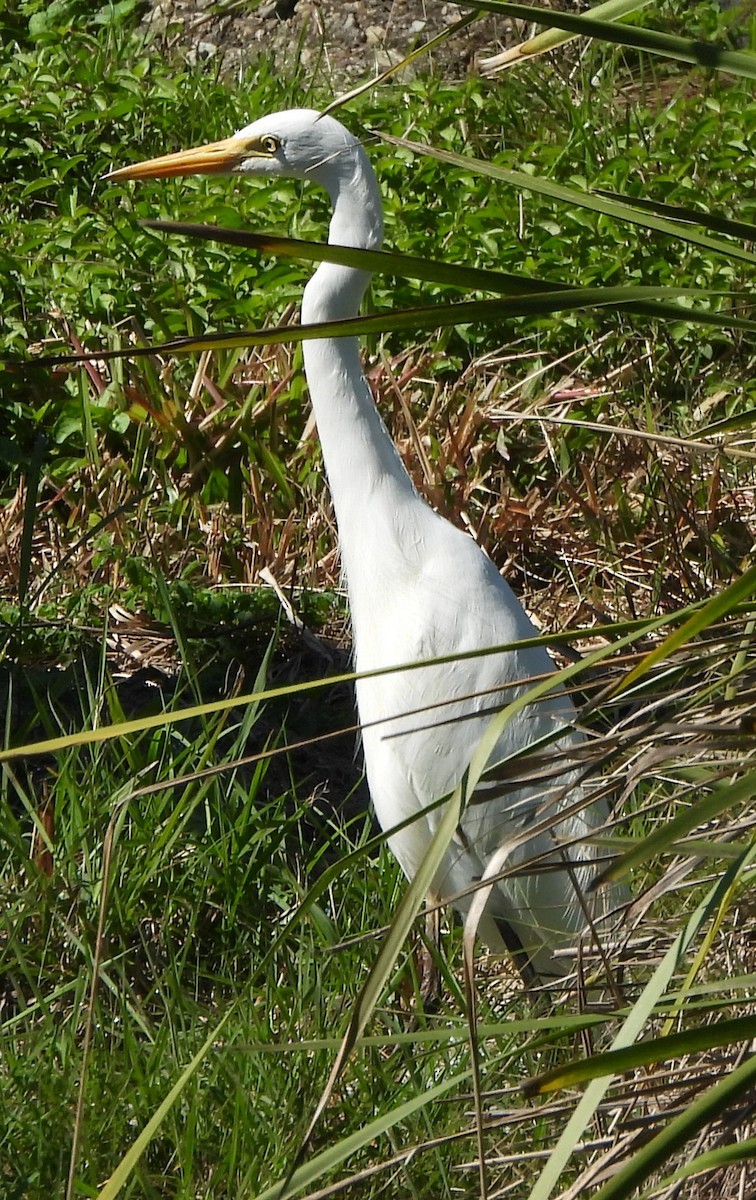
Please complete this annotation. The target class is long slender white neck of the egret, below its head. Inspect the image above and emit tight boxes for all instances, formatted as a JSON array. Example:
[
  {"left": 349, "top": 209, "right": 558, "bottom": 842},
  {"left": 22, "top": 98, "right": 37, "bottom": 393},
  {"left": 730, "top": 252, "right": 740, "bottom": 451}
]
[{"left": 302, "top": 142, "right": 421, "bottom": 619}]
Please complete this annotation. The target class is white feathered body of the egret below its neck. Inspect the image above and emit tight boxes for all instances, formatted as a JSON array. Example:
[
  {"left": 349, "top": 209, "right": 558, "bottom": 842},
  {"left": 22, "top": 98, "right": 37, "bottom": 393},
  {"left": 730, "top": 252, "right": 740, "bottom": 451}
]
[{"left": 358, "top": 511, "right": 606, "bottom": 970}]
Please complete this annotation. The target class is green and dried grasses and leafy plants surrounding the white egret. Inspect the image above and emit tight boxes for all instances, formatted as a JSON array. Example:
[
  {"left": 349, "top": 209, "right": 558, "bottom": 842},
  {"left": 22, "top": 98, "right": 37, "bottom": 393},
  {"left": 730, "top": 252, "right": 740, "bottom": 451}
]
[{"left": 0, "top": 0, "right": 756, "bottom": 1200}]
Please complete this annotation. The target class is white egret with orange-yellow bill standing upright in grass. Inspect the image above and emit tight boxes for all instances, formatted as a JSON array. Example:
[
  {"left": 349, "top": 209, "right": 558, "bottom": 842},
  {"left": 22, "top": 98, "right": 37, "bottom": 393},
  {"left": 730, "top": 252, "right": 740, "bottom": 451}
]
[{"left": 108, "top": 109, "right": 624, "bottom": 979}]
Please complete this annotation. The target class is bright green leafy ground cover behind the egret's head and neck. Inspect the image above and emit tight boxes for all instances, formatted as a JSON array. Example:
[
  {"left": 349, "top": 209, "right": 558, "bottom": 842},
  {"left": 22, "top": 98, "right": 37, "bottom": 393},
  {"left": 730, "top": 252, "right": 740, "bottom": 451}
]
[{"left": 0, "top": 36, "right": 756, "bottom": 609}]
